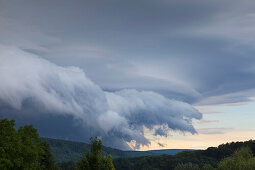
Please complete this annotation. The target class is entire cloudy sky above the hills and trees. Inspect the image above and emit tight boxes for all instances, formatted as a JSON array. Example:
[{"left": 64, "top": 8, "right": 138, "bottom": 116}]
[{"left": 0, "top": 0, "right": 255, "bottom": 150}]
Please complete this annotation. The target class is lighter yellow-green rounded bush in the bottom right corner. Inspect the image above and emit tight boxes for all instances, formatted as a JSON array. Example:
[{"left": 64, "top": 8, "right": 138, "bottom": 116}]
[{"left": 218, "top": 147, "right": 255, "bottom": 170}]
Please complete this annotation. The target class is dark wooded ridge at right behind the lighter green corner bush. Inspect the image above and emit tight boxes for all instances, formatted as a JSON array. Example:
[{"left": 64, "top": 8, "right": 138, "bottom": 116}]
[{"left": 113, "top": 140, "right": 255, "bottom": 170}]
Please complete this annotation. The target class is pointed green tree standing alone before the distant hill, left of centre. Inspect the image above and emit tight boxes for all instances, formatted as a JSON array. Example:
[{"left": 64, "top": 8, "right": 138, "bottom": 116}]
[{"left": 76, "top": 137, "right": 115, "bottom": 170}]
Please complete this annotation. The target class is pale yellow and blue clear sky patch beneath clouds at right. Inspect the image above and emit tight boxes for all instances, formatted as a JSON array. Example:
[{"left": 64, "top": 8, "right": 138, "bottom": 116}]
[{"left": 139, "top": 100, "right": 255, "bottom": 150}]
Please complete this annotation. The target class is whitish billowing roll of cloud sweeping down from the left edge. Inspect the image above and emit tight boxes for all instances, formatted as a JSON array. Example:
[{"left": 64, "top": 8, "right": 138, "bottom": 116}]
[{"left": 0, "top": 46, "right": 202, "bottom": 147}]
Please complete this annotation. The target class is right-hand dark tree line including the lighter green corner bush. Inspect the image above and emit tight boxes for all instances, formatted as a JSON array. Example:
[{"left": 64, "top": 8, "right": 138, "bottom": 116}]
[{"left": 113, "top": 140, "right": 255, "bottom": 170}]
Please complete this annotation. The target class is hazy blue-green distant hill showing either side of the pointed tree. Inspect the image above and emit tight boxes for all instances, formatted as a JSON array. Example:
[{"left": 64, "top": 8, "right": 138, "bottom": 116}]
[{"left": 43, "top": 138, "right": 191, "bottom": 162}]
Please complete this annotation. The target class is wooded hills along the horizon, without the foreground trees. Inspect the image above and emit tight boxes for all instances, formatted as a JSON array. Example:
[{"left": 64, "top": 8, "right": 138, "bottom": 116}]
[{"left": 44, "top": 138, "right": 255, "bottom": 170}]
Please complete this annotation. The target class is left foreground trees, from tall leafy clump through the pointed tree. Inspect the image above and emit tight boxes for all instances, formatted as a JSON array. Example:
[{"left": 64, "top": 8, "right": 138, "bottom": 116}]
[{"left": 0, "top": 119, "right": 115, "bottom": 170}]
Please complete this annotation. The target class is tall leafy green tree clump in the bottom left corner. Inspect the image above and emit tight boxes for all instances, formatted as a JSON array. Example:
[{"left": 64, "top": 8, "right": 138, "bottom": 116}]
[{"left": 0, "top": 119, "right": 58, "bottom": 170}]
